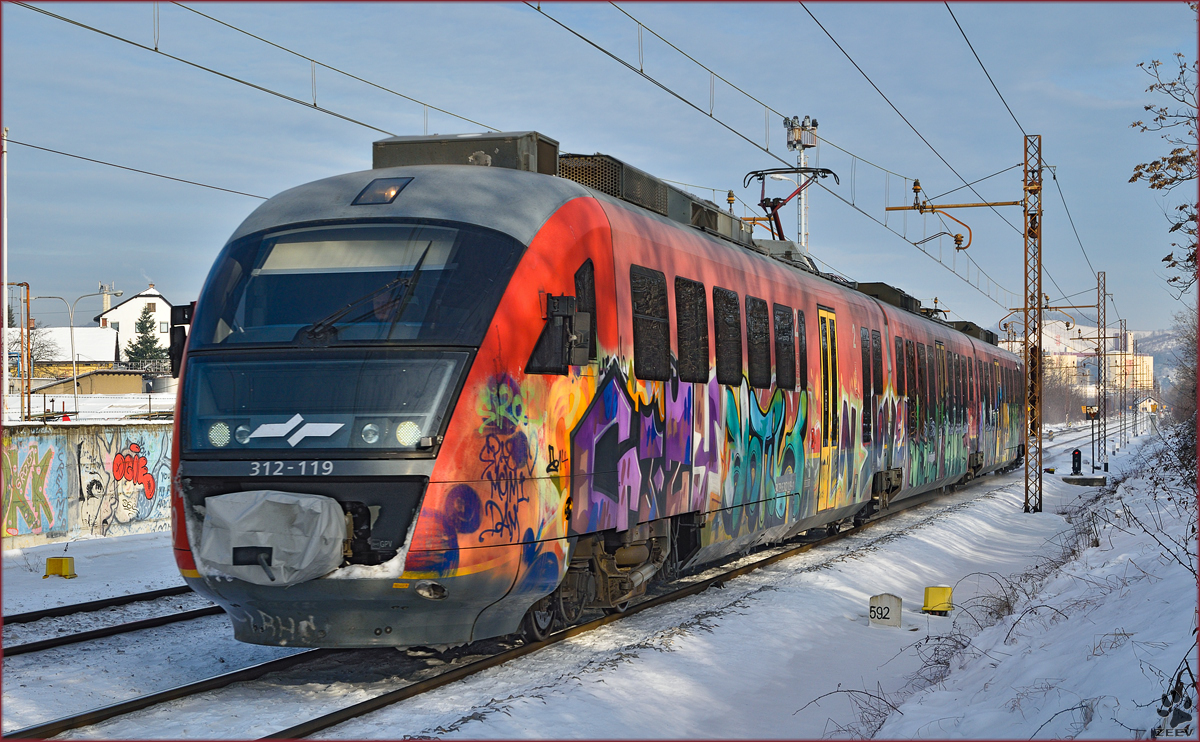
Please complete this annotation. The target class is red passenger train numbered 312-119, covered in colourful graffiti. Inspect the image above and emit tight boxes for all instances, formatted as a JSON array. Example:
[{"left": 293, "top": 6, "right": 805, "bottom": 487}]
[{"left": 172, "top": 132, "right": 1024, "bottom": 647}]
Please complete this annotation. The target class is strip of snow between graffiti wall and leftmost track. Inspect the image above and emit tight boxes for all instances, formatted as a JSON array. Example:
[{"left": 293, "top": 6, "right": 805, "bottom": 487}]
[{"left": 0, "top": 532, "right": 184, "bottom": 616}]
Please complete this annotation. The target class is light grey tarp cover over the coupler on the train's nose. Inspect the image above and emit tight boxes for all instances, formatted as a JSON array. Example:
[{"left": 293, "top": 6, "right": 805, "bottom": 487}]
[{"left": 196, "top": 490, "right": 346, "bottom": 586}]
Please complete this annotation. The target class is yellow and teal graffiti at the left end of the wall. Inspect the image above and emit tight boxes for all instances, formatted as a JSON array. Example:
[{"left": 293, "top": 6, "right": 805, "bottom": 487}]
[{"left": 4, "top": 436, "right": 68, "bottom": 535}]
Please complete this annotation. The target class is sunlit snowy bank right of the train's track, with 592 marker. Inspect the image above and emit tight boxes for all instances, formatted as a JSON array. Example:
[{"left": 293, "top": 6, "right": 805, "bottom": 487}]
[{"left": 309, "top": 425, "right": 1196, "bottom": 738}]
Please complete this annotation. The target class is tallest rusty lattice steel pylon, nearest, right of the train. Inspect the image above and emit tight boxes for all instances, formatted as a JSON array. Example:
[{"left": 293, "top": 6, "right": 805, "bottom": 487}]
[{"left": 1021, "top": 134, "right": 1042, "bottom": 513}]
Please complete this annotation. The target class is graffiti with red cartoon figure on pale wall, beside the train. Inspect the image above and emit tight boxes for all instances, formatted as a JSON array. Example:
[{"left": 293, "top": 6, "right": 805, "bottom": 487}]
[{"left": 77, "top": 426, "right": 170, "bottom": 535}]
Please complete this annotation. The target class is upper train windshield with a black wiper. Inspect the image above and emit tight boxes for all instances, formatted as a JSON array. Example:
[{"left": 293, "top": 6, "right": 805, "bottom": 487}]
[{"left": 190, "top": 222, "right": 522, "bottom": 351}]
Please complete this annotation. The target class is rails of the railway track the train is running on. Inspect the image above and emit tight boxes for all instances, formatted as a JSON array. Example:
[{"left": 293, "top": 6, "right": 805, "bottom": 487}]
[{"left": 4, "top": 470, "right": 1009, "bottom": 740}]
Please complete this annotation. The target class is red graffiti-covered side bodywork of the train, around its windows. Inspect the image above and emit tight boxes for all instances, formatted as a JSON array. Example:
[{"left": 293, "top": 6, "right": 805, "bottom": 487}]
[{"left": 407, "top": 190, "right": 1010, "bottom": 592}]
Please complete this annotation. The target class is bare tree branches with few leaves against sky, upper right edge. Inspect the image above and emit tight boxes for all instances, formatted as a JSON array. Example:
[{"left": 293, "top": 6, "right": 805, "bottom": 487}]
[{"left": 1129, "top": 9, "right": 1198, "bottom": 297}]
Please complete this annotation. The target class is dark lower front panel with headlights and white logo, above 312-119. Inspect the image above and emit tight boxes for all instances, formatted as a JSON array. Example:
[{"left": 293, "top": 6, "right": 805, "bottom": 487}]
[{"left": 181, "top": 348, "right": 469, "bottom": 454}]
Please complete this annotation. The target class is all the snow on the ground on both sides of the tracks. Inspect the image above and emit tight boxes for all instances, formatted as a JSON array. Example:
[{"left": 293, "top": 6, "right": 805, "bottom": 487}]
[{"left": 5, "top": 415, "right": 1196, "bottom": 738}]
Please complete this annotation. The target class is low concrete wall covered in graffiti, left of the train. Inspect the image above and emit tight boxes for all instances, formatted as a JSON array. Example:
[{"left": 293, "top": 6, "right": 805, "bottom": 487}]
[{"left": 2, "top": 421, "right": 172, "bottom": 549}]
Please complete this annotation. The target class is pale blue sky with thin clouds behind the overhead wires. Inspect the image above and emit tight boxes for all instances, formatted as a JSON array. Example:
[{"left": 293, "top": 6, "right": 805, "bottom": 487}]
[{"left": 0, "top": 2, "right": 1198, "bottom": 330}]
